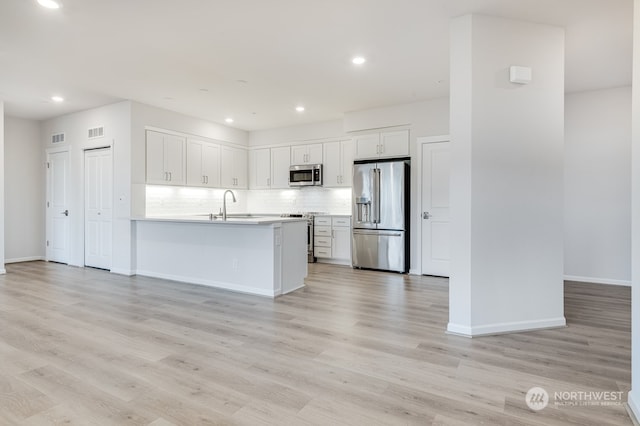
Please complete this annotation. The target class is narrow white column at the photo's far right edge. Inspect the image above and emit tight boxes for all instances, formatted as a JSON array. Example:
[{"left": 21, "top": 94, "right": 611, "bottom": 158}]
[{"left": 628, "top": 0, "right": 640, "bottom": 419}]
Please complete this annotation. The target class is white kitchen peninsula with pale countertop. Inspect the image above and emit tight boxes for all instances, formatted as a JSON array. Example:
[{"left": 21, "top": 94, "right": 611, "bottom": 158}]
[{"left": 133, "top": 215, "right": 307, "bottom": 297}]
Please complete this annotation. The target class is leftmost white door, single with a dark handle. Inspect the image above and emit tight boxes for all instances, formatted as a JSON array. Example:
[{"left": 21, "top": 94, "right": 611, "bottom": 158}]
[{"left": 46, "top": 151, "right": 69, "bottom": 263}]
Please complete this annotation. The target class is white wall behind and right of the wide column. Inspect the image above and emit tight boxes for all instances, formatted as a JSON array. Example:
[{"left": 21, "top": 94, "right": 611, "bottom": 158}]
[{"left": 564, "top": 87, "right": 631, "bottom": 285}]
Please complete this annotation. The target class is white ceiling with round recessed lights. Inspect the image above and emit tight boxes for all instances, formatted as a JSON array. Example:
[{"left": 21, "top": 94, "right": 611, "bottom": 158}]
[{"left": 0, "top": 0, "right": 633, "bottom": 130}]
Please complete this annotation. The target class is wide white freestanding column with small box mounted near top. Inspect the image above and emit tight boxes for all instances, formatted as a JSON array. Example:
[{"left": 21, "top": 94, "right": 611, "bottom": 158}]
[{"left": 448, "top": 15, "right": 565, "bottom": 336}]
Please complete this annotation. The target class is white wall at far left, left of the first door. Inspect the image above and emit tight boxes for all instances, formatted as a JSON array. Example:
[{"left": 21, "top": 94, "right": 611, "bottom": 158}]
[{"left": 4, "top": 117, "right": 45, "bottom": 263}]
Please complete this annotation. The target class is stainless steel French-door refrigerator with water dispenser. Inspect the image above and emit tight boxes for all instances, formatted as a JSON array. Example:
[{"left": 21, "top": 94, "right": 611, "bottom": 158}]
[{"left": 351, "top": 158, "right": 410, "bottom": 273}]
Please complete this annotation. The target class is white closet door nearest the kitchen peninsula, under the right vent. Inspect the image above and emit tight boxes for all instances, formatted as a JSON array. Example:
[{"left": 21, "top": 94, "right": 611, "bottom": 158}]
[{"left": 84, "top": 148, "right": 113, "bottom": 269}]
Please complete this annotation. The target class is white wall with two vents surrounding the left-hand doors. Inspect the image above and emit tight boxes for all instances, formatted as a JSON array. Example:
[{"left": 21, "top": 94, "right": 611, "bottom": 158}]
[{"left": 41, "top": 102, "right": 133, "bottom": 274}]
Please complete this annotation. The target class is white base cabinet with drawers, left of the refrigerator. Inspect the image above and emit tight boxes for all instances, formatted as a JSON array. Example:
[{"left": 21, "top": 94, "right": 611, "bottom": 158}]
[{"left": 313, "top": 216, "right": 351, "bottom": 265}]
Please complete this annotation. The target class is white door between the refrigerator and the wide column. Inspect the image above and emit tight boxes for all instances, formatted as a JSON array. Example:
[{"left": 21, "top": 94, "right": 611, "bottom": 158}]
[{"left": 421, "top": 142, "right": 451, "bottom": 277}]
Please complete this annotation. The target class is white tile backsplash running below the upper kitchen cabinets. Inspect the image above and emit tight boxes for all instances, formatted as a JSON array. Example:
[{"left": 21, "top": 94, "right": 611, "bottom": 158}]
[{"left": 146, "top": 185, "right": 351, "bottom": 216}]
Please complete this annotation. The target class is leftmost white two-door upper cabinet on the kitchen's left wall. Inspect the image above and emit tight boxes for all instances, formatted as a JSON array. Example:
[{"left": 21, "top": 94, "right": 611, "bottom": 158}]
[{"left": 146, "top": 130, "right": 186, "bottom": 185}]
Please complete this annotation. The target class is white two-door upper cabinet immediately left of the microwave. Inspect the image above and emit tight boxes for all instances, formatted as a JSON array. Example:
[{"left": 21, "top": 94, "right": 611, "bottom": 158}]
[{"left": 249, "top": 146, "right": 291, "bottom": 189}]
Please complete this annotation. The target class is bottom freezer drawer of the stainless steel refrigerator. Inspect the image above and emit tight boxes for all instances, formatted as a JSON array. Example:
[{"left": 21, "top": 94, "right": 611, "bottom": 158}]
[{"left": 351, "top": 229, "right": 408, "bottom": 272}]
